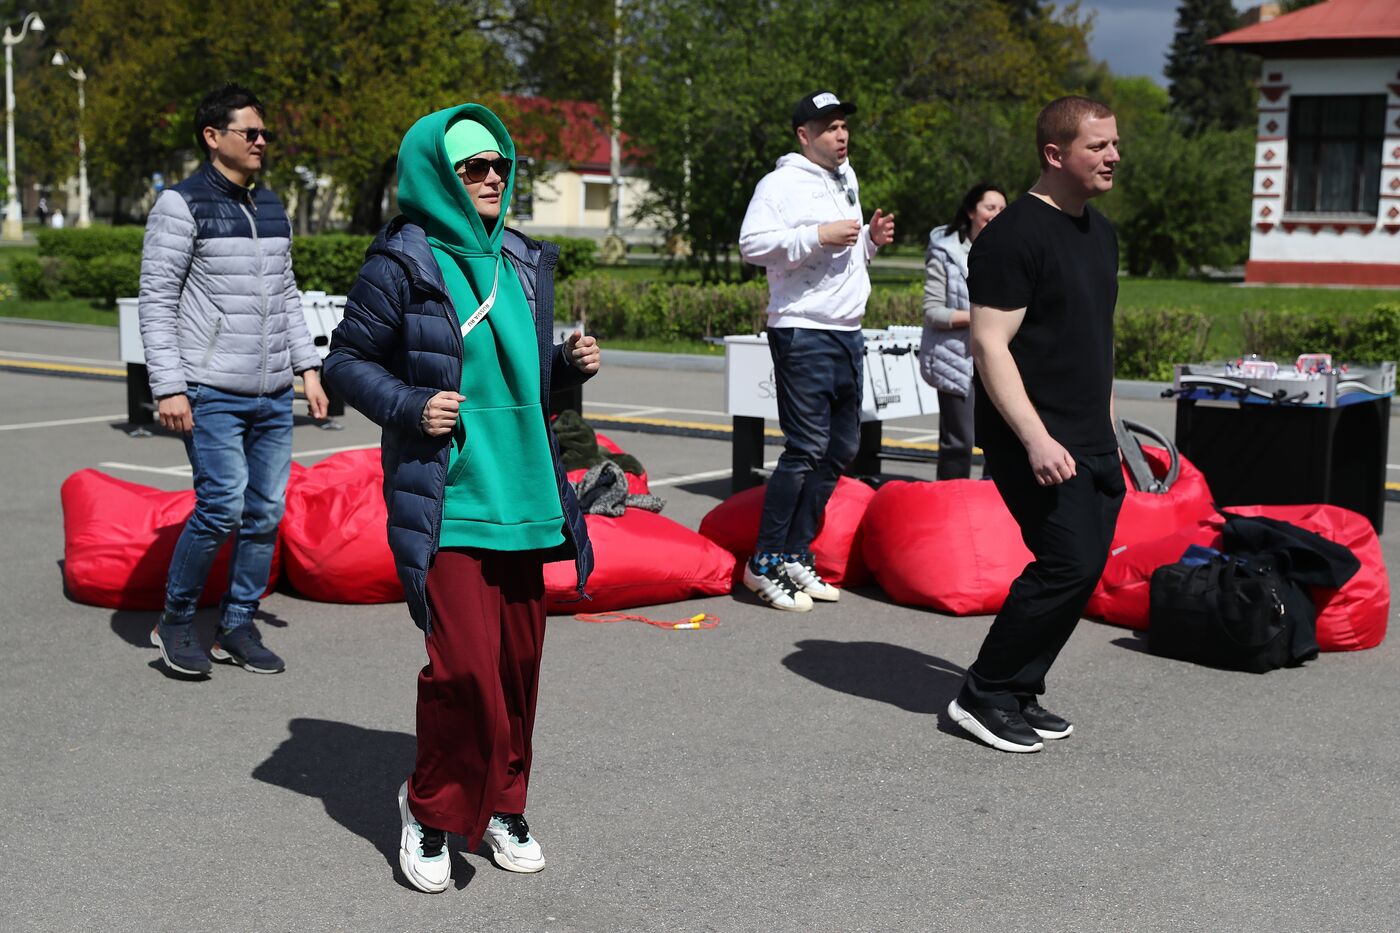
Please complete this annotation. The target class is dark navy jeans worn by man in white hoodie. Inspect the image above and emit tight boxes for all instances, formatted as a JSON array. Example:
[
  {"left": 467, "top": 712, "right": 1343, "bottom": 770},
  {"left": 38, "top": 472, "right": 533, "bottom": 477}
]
[{"left": 757, "top": 328, "right": 865, "bottom": 553}]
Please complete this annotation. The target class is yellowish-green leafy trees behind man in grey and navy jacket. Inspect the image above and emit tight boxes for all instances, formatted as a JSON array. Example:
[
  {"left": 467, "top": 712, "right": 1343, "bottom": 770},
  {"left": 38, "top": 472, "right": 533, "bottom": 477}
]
[{"left": 31, "top": 0, "right": 514, "bottom": 231}]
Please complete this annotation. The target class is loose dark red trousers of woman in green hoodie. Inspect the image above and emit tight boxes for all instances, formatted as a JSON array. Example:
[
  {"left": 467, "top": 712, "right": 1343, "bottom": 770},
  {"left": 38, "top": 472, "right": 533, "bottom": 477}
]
[{"left": 409, "top": 548, "right": 545, "bottom": 848}]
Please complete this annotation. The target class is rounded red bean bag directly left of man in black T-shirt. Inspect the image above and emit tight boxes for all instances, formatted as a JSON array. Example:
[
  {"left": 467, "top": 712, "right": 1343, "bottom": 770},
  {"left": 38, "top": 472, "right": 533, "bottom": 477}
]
[{"left": 861, "top": 479, "right": 1032, "bottom": 615}]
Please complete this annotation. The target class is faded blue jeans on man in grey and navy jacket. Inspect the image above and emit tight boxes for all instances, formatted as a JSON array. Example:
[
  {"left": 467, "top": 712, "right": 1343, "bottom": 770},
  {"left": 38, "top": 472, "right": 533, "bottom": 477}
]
[{"left": 165, "top": 385, "right": 293, "bottom": 629}]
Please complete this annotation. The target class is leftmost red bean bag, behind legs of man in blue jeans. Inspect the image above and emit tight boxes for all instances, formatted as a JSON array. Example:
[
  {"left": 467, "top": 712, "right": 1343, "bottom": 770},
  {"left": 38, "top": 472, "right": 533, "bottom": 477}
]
[{"left": 59, "top": 469, "right": 281, "bottom": 609}]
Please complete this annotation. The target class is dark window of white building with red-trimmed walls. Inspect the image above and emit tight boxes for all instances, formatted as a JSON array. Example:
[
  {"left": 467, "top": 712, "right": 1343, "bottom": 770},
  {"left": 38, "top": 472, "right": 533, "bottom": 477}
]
[{"left": 1285, "top": 94, "right": 1386, "bottom": 217}]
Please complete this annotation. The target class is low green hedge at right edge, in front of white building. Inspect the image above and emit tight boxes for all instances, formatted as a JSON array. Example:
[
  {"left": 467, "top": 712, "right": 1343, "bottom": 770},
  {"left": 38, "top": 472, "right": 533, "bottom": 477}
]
[{"left": 1243, "top": 303, "right": 1400, "bottom": 363}]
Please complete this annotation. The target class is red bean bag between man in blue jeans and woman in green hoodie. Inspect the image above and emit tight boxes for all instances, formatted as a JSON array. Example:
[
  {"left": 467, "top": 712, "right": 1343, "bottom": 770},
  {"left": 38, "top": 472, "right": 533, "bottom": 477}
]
[{"left": 281, "top": 448, "right": 403, "bottom": 602}]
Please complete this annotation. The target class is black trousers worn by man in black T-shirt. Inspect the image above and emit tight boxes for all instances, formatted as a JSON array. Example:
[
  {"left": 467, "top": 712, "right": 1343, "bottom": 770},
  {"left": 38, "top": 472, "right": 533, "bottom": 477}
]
[{"left": 958, "top": 441, "right": 1127, "bottom": 710}]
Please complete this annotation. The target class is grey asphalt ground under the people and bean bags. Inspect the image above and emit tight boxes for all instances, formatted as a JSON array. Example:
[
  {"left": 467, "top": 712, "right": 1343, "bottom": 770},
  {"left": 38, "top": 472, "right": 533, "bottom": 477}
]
[{"left": 0, "top": 316, "right": 1400, "bottom": 932}]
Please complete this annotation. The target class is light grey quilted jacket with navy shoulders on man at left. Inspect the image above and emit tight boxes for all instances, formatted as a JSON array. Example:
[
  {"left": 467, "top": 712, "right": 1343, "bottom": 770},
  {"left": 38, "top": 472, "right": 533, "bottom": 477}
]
[{"left": 140, "top": 163, "right": 321, "bottom": 398}]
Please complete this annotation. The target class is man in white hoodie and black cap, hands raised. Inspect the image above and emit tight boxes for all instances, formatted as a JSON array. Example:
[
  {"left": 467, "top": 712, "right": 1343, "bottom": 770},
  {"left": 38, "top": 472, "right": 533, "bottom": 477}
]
[{"left": 739, "top": 91, "right": 895, "bottom": 612}]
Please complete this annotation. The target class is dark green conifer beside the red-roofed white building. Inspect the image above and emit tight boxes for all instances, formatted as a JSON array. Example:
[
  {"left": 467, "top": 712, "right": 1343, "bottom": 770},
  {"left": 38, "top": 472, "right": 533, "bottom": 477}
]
[{"left": 1166, "top": 0, "right": 1259, "bottom": 136}]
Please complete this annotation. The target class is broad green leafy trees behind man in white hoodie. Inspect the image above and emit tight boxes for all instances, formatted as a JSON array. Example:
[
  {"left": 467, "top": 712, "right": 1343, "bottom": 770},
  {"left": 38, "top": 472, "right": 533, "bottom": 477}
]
[{"left": 622, "top": 0, "right": 1096, "bottom": 279}]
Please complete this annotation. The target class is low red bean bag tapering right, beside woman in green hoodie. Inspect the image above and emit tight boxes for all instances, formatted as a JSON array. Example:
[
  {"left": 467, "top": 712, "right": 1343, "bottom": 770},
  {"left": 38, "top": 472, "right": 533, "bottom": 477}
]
[{"left": 545, "top": 509, "right": 734, "bottom": 615}]
